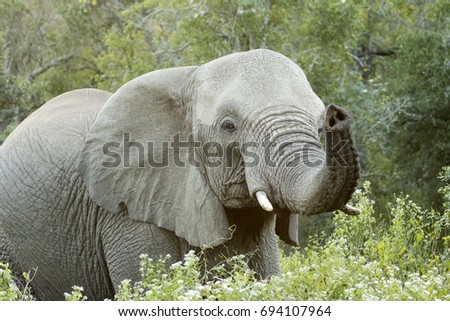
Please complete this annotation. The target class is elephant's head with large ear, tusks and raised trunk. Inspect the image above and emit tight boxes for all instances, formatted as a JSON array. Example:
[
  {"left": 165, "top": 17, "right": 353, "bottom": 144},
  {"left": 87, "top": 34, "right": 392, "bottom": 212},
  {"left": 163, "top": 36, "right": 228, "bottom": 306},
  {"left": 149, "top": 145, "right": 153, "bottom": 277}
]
[{"left": 78, "top": 50, "right": 359, "bottom": 246}]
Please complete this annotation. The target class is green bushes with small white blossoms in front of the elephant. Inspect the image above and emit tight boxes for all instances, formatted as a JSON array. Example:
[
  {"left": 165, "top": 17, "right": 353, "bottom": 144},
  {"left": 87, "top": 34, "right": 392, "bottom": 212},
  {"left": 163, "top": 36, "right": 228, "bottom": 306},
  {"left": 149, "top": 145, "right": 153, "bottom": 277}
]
[{"left": 0, "top": 167, "right": 450, "bottom": 301}]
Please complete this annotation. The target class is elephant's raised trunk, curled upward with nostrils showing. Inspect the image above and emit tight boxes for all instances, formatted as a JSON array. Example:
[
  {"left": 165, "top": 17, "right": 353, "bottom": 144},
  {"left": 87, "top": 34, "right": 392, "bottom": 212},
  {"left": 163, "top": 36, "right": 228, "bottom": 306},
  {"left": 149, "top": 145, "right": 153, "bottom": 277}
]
[{"left": 250, "top": 105, "right": 359, "bottom": 215}]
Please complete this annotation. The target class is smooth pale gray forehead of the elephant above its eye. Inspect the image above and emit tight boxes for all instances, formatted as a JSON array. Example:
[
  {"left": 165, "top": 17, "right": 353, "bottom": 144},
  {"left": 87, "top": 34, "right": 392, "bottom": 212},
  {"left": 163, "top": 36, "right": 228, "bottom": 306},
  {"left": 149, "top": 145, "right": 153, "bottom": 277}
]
[{"left": 197, "top": 50, "right": 324, "bottom": 123}]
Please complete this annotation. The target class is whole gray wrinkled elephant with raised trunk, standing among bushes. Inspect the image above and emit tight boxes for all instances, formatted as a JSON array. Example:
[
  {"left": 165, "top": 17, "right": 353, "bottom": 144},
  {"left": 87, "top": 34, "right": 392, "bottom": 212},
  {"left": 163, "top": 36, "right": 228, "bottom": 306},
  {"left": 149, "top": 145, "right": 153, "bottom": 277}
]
[{"left": 0, "top": 50, "right": 358, "bottom": 300}]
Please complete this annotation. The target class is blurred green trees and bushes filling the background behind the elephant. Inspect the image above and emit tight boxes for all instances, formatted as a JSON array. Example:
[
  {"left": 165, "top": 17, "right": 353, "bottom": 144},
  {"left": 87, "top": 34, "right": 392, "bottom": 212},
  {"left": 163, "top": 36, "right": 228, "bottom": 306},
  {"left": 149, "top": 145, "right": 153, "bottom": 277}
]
[{"left": 0, "top": 0, "right": 450, "bottom": 298}]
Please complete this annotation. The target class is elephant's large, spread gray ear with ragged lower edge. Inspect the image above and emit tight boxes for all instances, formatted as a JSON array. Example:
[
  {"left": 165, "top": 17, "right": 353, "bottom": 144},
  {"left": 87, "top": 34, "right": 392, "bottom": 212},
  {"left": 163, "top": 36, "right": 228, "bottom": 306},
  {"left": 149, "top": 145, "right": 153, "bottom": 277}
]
[{"left": 77, "top": 67, "right": 231, "bottom": 246}]
